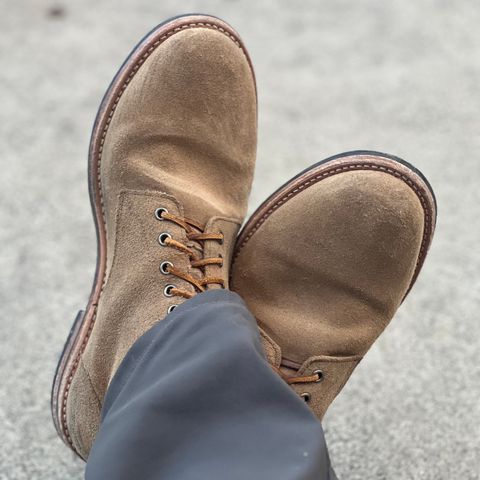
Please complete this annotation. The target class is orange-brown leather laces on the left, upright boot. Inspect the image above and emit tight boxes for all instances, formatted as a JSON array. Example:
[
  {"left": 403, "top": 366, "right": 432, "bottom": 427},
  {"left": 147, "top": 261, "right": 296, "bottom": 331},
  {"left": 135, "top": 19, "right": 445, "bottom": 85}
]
[{"left": 160, "top": 210, "right": 225, "bottom": 299}]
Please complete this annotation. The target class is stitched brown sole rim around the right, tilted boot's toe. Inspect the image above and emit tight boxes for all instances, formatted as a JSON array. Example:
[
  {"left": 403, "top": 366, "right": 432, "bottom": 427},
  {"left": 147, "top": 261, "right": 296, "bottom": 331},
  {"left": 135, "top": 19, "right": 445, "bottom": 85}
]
[{"left": 231, "top": 150, "right": 437, "bottom": 298}]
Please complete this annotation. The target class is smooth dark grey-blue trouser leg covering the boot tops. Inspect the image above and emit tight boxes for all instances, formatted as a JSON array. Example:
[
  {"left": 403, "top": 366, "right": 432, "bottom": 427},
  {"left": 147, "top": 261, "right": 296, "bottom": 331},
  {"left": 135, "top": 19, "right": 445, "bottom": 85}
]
[{"left": 86, "top": 290, "right": 336, "bottom": 480}]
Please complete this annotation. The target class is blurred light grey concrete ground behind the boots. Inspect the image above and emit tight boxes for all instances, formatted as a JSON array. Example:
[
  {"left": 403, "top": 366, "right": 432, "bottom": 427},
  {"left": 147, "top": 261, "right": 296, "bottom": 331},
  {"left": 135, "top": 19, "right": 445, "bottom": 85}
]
[{"left": 0, "top": 0, "right": 480, "bottom": 480}]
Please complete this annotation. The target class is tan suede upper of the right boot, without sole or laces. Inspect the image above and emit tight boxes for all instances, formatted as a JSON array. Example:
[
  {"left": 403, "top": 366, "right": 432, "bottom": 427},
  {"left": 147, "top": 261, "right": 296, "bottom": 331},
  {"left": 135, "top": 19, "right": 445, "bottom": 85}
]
[{"left": 232, "top": 171, "right": 424, "bottom": 418}]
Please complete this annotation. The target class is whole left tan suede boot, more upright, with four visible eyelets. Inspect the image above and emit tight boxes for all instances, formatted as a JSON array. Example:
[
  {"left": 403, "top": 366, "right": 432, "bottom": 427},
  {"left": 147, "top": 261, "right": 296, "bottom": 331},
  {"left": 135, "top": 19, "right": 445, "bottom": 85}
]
[{"left": 52, "top": 15, "right": 257, "bottom": 459}]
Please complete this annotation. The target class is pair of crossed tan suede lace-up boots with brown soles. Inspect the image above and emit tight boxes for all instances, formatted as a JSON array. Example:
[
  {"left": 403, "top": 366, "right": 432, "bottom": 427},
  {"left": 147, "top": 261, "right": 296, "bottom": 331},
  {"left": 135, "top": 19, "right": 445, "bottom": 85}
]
[{"left": 52, "top": 15, "right": 436, "bottom": 459}]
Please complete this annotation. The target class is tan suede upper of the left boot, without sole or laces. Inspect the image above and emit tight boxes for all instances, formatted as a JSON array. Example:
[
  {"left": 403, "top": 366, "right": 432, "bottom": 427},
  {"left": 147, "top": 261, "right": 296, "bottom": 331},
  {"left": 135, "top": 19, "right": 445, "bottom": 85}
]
[{"left": 67, "top": 28, "right": 257, "bottom": 458}]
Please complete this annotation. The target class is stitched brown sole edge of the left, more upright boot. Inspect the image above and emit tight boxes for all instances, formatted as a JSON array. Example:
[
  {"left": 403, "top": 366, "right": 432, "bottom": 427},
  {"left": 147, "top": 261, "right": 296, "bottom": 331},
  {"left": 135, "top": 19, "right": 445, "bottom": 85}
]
[{"left": 51, "top": 14, "right": 255, "bottom": 458}]
